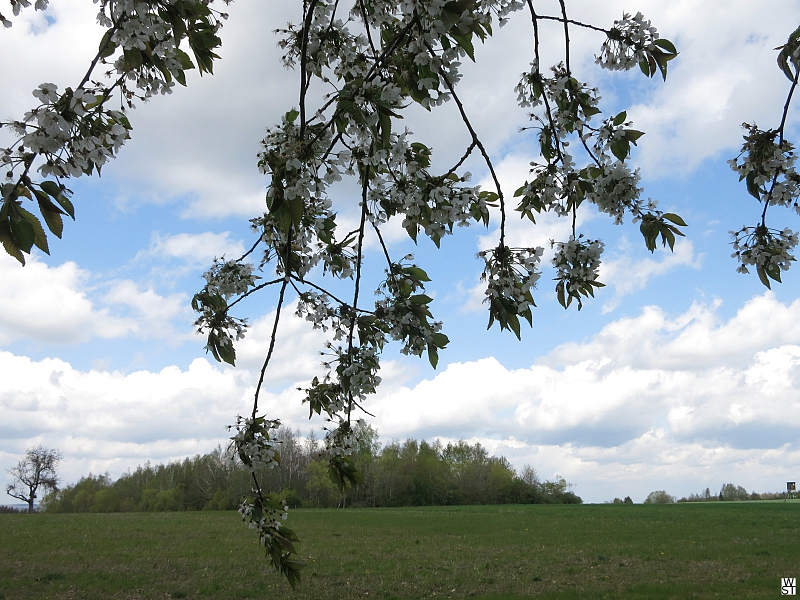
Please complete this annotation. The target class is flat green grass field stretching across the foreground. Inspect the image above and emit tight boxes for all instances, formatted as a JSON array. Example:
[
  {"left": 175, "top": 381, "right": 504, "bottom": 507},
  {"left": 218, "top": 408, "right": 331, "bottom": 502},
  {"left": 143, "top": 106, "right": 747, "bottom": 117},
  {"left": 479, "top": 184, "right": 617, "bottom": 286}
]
[{"left": 0, "top": 502, "right": 800, "bottom": 600}]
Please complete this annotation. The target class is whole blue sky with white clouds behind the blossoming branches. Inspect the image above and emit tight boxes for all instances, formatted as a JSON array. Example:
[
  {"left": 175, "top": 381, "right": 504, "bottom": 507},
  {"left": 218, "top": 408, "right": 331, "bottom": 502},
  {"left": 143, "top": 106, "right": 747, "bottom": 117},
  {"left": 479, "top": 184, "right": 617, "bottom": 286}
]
[{"left": 0, "top": 0, "right": 800, "bottom": 502}]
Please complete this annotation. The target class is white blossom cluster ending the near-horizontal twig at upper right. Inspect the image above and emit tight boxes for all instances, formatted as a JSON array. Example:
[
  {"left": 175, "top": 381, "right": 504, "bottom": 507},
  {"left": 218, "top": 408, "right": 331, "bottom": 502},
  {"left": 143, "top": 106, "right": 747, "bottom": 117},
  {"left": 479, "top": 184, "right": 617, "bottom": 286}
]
[{"left": 595, "top": 12, "right": 659, "bottom": 71}]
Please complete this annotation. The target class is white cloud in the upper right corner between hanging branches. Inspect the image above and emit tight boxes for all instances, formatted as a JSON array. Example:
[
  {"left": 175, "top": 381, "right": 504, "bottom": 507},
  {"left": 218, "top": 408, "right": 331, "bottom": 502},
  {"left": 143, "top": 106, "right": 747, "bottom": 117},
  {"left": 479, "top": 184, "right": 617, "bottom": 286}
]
[{"left": 628, "top": 0, "right": 800, "bottom": 177}]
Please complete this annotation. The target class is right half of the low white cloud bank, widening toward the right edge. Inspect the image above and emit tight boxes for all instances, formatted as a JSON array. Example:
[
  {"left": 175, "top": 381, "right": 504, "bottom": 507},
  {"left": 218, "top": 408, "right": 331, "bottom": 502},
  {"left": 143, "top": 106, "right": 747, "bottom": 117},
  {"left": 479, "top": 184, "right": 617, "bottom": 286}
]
[{"left": 369, "top": 293, "right": 800, "bottom": 499}]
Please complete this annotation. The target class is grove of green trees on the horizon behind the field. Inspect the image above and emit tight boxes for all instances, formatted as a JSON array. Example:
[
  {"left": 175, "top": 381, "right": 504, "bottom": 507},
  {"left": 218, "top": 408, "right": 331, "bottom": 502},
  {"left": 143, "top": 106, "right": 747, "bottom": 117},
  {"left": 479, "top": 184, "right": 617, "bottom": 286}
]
[{"left": 41, "top": 427, "right": 582, "bottom": 513}]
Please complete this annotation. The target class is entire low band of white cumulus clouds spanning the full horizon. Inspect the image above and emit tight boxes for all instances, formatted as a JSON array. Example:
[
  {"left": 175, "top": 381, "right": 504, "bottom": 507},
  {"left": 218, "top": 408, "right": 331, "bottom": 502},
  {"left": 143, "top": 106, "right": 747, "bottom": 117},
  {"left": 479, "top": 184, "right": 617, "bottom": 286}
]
[{"left": 0, "top": 292, "right": 800, "bottom": 500}]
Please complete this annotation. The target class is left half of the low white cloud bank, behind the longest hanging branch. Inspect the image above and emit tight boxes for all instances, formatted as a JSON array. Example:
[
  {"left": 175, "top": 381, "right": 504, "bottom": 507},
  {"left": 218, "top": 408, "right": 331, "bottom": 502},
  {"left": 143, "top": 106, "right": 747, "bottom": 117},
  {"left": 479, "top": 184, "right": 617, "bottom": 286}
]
[{"left": 0, "top": 298, "right": 408, "bottom": 500}]
